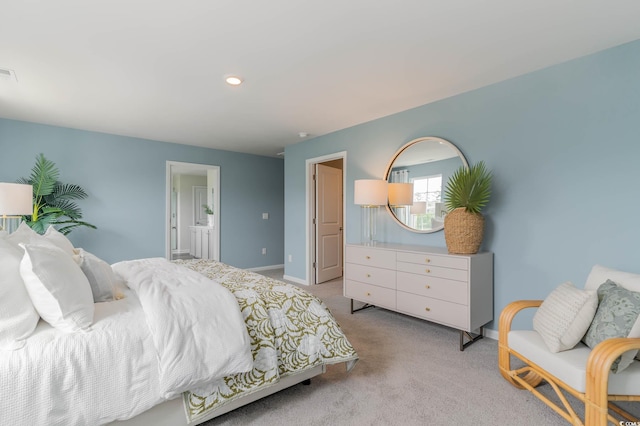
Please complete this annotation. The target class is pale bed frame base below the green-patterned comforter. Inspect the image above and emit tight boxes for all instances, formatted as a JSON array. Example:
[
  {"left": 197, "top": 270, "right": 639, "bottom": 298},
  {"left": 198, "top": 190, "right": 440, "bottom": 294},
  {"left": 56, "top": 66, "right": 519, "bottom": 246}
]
[{"left": 110, "top": 365, "right": 326, "bottom": 426}]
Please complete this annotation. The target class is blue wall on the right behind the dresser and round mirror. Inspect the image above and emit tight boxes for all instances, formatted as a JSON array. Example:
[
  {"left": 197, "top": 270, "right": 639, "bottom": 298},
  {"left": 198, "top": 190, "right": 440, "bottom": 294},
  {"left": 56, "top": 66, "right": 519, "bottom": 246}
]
[{"left": 285, "top": 41, "right": 640, "bottom": 328}]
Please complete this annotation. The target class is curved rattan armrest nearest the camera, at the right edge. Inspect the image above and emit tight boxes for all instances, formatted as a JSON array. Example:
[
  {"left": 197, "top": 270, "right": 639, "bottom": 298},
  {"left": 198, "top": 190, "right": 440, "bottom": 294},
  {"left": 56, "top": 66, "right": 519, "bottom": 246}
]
[{"left": 585, "top": 337, "right": 640, "bottom": 424}]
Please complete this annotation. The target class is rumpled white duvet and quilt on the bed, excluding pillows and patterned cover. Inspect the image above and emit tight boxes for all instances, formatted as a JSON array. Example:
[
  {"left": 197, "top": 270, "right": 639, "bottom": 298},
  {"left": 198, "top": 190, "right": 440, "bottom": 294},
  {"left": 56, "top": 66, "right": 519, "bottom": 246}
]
[{"left": 0, "top": 259, "right": 251, "bottom": 426}]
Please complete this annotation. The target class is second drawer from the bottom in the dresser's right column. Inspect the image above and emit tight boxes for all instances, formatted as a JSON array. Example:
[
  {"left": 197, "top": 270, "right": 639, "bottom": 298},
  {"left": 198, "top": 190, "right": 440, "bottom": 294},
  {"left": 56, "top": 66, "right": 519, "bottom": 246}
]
[{"left": 396, "top": 272, "right": 469, "bottom": 305}]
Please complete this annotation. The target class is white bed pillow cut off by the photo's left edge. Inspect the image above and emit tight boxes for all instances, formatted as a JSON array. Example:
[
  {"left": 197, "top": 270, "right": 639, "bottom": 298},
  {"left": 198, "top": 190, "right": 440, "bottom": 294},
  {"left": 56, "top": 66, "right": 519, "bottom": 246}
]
[{"left": 0, "top": 239, "right": 40, "bottom": 350}]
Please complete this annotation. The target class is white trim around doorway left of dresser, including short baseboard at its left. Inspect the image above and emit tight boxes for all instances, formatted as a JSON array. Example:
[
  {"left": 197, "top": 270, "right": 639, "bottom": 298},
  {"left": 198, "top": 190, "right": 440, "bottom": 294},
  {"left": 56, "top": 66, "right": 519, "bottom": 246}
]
[{"left": 304, "top": 151, "right": 347, "bottom": 285}]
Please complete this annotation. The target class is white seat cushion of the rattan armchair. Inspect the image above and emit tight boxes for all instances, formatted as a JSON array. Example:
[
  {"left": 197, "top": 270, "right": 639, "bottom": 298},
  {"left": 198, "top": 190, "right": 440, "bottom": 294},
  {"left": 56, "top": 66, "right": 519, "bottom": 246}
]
[{"left": 507, "top": 330, "right": 640, "bottom": 395}]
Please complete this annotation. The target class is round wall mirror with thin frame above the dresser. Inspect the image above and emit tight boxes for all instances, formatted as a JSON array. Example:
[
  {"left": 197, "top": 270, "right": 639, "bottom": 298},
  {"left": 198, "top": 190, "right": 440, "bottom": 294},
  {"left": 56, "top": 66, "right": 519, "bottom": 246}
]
[{"left": 384, "top": 136, "right": 469, "bottom": 233}]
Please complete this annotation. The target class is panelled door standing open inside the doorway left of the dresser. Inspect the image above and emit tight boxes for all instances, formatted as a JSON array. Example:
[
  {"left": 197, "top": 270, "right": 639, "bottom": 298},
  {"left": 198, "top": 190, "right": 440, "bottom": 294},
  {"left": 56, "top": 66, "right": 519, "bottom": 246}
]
[{"left": 315, "top": 164, "right": 342, "bottom": 284}]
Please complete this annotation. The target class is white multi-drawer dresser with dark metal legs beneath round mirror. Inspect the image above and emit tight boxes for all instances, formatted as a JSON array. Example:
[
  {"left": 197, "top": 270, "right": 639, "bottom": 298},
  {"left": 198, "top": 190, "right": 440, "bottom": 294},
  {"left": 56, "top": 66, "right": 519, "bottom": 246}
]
[{"left": 344, "top": 243, "right": 493, "bottom": 350}]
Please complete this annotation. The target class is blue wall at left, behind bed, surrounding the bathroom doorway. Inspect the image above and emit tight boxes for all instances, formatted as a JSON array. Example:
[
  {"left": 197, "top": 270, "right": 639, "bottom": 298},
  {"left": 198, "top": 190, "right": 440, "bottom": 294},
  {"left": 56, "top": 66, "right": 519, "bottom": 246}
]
[{"left": 0, "top": 119, "right": 284, "bottom": 268}]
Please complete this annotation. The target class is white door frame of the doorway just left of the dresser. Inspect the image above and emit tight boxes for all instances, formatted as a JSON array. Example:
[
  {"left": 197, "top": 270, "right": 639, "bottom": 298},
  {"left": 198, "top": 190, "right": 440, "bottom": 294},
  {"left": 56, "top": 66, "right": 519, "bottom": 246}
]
[{"left": 305, "top": 151, "right": 347, "bottom": 285}]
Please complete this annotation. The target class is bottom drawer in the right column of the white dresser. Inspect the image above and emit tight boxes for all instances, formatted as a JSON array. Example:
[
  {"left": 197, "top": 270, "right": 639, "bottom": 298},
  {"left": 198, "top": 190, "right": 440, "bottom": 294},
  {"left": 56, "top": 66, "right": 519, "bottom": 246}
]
[{"left": 396, "top": 291, "right": 470, "bottom": 331}]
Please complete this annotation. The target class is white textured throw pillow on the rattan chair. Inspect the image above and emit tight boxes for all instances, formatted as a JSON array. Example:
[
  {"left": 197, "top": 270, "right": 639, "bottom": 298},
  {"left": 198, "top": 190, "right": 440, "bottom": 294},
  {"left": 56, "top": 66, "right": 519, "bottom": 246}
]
[{"left": 533, "top": 282, "right": 598, "bottom": 353}]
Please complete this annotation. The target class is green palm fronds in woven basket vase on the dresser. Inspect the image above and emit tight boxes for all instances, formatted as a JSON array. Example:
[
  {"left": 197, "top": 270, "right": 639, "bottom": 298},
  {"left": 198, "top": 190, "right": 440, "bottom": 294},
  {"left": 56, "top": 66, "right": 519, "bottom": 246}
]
[{"left": 444, "top": 161, "right": 492, "bottom": 254}]
